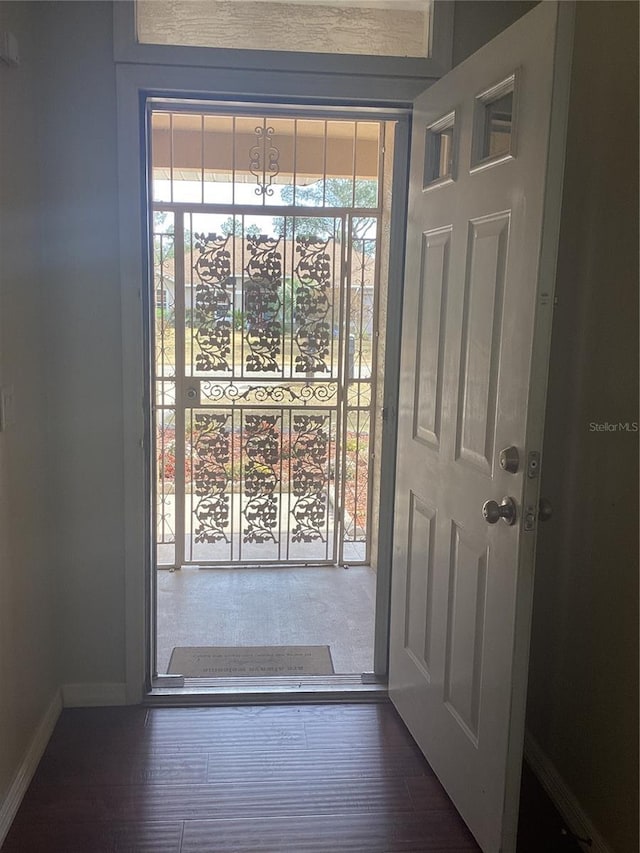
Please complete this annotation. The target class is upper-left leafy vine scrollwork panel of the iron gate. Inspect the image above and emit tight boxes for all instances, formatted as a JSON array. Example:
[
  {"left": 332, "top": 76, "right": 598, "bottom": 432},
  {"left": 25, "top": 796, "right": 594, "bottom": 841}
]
[{"left": 194, "top": 234, "right": 233, "bottom": 371}]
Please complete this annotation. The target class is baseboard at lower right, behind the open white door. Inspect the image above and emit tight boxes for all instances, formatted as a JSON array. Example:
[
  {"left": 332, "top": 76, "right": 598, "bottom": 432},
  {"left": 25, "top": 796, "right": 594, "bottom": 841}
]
[{"left": 524, "top": 732, "right": 612, "bottom": 853}]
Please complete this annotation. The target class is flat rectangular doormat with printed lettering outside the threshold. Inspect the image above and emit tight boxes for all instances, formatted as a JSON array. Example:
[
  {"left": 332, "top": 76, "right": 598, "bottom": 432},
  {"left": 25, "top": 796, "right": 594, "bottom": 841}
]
[{"left": 168, "top": 646, "right": 334, "bottom": 678}]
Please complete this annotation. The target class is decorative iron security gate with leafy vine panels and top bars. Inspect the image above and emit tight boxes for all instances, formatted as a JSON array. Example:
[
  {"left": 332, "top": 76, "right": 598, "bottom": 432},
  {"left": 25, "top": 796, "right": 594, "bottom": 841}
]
[{"left": 151, "top": 112, "right": 381, "bottom": 567}]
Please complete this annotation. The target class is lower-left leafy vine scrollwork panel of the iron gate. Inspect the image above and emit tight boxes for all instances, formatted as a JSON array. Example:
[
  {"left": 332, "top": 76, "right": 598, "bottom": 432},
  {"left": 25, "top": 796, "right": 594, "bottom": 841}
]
[{"left": 194, "top": 413, "right": 231, "bottom": 543}]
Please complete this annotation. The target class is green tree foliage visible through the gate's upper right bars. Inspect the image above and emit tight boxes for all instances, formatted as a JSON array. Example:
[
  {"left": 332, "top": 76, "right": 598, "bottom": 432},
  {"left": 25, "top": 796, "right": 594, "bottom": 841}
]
[{"left": 273, "top": 178, "right": 378, "bottom": 248}]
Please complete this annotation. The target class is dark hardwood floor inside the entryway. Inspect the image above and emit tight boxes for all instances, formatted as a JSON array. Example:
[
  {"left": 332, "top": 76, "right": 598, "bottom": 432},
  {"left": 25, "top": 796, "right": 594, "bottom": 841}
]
[{"left": 2, "top": 703, "right": 577, "bottom": 853}]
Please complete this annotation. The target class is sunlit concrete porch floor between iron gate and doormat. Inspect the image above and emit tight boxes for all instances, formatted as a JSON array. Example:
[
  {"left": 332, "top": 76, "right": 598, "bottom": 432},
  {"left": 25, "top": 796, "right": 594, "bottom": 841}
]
[{"left": 157, "top": 566, "right": 376, "bottom": 674}]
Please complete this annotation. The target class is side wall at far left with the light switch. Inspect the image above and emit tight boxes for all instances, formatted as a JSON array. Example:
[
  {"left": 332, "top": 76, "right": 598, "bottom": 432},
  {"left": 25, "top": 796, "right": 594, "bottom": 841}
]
[{"left": 0, "top": 3, "right": 58, "bottom": 807}]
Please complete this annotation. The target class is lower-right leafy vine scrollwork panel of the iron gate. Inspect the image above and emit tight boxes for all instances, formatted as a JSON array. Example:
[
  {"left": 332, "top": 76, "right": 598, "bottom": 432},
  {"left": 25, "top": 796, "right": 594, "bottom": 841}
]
[{"left": 291, "top": 414, "right": 329, "bottom": 542}]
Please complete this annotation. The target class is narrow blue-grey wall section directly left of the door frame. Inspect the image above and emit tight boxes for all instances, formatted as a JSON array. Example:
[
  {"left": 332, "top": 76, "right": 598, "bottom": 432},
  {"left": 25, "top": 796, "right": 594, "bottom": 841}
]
[{"left": 37, "top": 2, "right": 124, "bottom": 684}]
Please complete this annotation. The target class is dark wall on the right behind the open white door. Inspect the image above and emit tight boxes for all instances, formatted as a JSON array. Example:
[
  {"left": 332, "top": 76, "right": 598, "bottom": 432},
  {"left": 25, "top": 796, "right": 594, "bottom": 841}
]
[{"left": 528, "top": 2, "right": 640, "bottom": 853}]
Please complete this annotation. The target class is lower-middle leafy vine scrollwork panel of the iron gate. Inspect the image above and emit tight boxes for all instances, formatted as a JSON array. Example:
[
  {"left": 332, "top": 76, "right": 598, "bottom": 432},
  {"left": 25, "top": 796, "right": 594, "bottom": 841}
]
[{"left": 242, "top": 414, "right": 280, "bottom": 542}]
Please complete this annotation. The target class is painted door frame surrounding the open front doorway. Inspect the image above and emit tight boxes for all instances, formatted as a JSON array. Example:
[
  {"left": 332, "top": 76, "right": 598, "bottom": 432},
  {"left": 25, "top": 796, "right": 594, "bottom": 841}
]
[{"left": 116, "top": 64, "right": 412, "bottom": 704}]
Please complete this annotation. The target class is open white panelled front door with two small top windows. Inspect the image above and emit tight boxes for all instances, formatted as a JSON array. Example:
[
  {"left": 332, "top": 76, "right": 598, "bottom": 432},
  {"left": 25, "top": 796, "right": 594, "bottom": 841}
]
[{"left": 389, "top": 2, "right": 572, "bottom": 853}]
